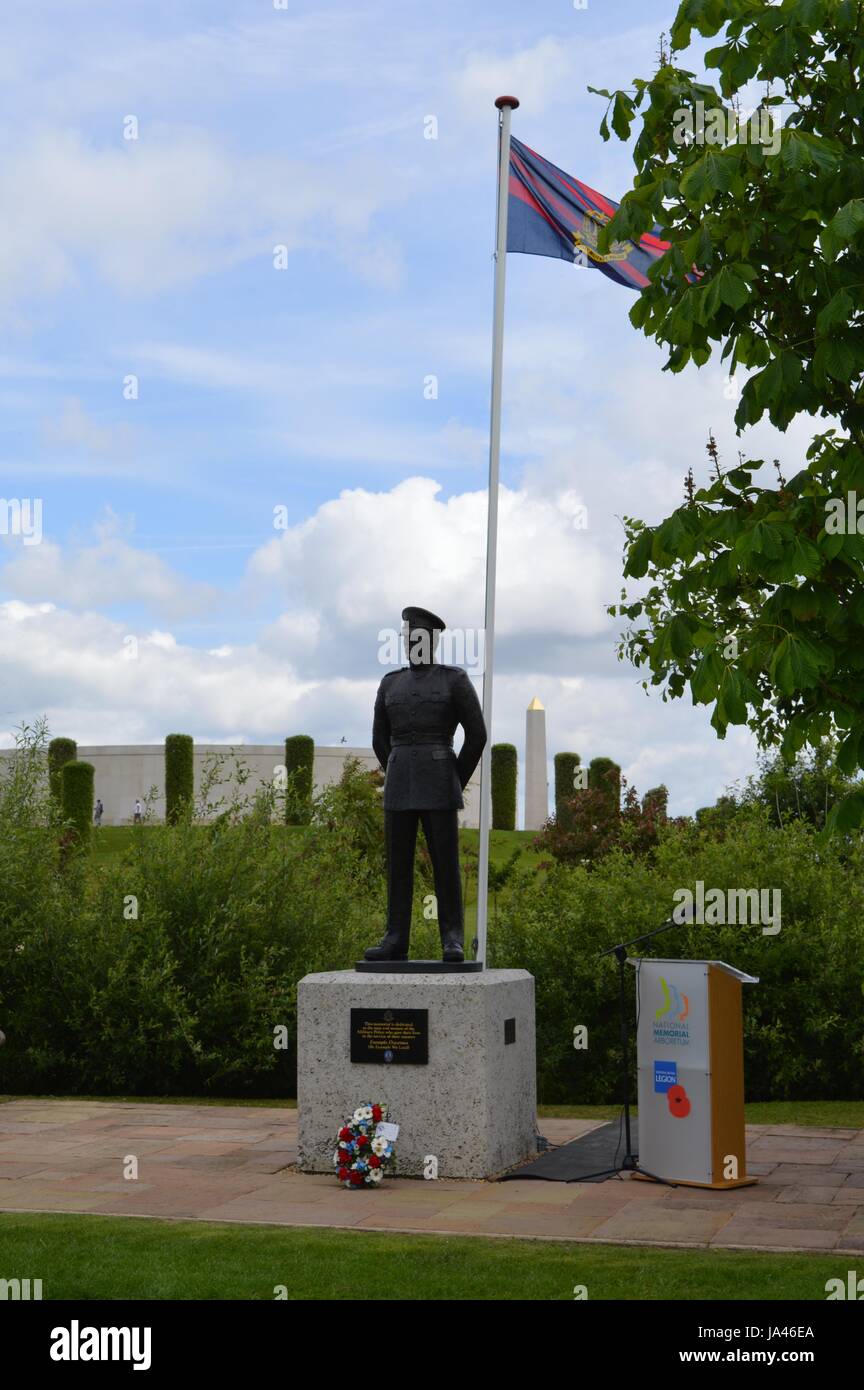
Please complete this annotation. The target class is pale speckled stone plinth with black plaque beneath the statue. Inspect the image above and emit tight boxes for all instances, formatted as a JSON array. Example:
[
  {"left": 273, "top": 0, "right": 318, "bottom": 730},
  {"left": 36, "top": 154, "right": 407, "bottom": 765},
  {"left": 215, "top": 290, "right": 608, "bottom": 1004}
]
[{"left": 297, "top": 970, "right": 536, "bottom": 1177}]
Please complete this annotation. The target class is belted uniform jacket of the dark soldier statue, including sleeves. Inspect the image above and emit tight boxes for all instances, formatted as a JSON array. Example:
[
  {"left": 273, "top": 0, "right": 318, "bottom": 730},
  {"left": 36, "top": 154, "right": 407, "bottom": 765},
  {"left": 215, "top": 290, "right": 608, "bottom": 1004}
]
[{"left": 372, "top": 663, "right": 486, "bottom": 810}]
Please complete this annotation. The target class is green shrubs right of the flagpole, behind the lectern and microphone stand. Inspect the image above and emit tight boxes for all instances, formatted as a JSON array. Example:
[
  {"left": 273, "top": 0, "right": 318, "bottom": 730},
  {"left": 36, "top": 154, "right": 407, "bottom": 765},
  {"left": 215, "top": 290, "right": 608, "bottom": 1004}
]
[{"left": 489, "top": 810, "right": 864, "bottom": 1102}]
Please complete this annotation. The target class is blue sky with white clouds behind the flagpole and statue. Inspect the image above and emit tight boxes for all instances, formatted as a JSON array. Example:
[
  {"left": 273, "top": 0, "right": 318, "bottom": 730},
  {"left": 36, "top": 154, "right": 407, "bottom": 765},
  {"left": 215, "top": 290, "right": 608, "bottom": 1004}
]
[{"left": 0, "top": 0, "right": 807, "bottom": 812}]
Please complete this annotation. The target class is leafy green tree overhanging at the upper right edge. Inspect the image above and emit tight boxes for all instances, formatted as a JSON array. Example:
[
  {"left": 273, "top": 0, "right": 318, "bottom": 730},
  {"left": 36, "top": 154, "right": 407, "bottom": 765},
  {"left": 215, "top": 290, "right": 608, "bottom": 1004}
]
[{"left": 599, "top": 0, "right": 864, "bottom": 828}]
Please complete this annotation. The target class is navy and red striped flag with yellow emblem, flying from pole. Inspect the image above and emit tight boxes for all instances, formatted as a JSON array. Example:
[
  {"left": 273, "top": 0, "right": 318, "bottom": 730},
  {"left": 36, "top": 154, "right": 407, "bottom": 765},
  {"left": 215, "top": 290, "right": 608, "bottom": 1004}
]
[{"left": 507, "top": 138, "right": 696, "bottom": 289}]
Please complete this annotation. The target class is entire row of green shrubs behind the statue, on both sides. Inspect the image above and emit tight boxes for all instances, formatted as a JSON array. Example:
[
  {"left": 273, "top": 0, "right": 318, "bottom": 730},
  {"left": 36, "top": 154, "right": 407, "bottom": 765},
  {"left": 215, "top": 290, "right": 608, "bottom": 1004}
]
[{"left": 0, "top": 730, "right": 864, "bottom": 1102}]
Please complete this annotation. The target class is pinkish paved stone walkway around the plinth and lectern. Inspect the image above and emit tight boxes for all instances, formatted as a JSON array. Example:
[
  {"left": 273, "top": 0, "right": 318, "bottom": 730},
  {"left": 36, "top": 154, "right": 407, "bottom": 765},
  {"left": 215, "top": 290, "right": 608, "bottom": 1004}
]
[{"left": 0, "top": 1101, "right": 864, "bottom": 1254}]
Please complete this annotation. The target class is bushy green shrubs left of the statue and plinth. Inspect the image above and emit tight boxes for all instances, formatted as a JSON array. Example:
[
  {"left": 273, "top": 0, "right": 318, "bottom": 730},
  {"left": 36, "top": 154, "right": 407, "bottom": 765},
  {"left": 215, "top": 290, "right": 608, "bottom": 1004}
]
[{"left": 0, "top": 763, "right": 419, "bottom": 1095}]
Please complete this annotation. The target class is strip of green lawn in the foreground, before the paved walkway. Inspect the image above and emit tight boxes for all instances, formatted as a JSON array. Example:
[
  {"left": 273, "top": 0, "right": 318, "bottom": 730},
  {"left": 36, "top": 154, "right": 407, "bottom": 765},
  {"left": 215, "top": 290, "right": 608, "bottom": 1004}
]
[{"left": 0, "top": 1217, "right": 845, "bottom": 1301}]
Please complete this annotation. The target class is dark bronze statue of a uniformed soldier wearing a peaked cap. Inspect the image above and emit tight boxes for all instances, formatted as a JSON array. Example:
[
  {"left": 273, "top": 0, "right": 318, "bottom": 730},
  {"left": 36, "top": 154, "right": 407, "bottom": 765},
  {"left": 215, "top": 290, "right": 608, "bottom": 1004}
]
[{"left": 365, "top": 607, "right": 486, "bottom": 963}]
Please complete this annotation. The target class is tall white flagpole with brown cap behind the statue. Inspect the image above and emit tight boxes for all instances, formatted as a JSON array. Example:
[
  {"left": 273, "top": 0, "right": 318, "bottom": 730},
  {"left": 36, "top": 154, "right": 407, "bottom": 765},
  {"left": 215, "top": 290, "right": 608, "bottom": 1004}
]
[{"left": 475, "top": 96, "right": 520, "bottom": 965}]
